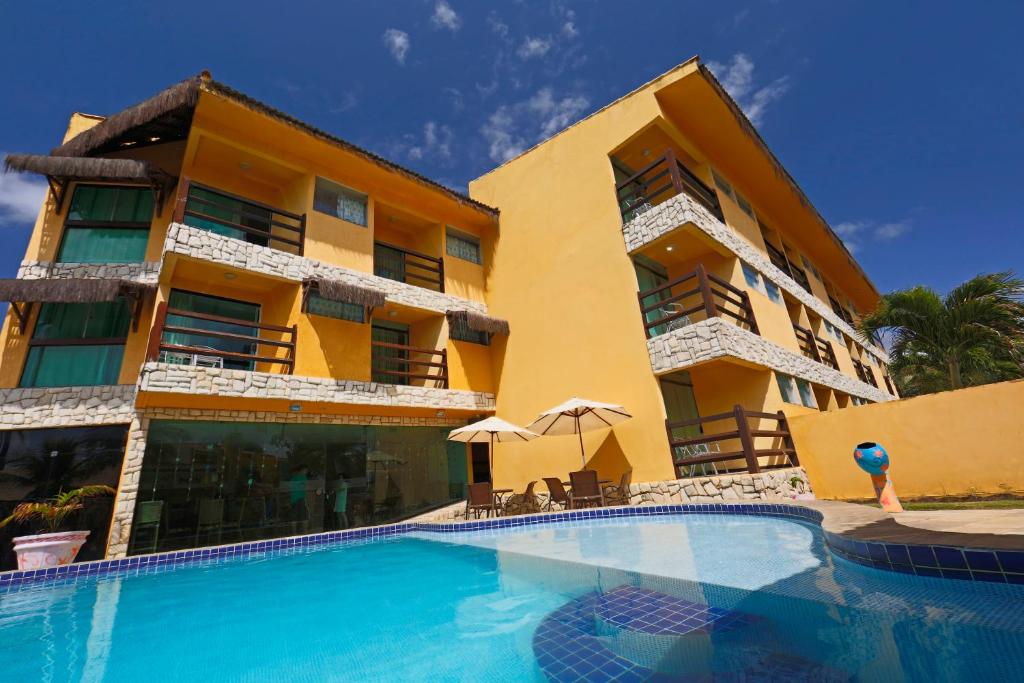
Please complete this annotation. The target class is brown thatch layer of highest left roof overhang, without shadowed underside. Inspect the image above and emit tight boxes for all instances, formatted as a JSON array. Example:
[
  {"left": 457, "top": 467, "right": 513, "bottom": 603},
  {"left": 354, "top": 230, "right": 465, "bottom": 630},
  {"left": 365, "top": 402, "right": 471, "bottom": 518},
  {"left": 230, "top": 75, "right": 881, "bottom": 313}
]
[{"left": 51, "top": 74, "right": 201, "bottom": 157}]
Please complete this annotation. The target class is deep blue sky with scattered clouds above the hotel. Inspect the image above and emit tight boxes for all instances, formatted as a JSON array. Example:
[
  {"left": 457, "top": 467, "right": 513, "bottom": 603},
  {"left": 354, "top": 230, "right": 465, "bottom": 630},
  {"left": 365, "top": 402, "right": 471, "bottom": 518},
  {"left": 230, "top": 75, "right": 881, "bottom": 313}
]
[{"left": 0, "top": 0, "right": 1024, "bottom": 291}]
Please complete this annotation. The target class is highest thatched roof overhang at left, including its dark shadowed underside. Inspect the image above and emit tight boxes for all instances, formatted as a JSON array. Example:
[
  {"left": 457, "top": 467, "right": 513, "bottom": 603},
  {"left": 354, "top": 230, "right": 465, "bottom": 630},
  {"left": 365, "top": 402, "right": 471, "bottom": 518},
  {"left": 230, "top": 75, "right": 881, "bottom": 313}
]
[{"left": 52, "top": 76, "right": 203, "bottom": 157}]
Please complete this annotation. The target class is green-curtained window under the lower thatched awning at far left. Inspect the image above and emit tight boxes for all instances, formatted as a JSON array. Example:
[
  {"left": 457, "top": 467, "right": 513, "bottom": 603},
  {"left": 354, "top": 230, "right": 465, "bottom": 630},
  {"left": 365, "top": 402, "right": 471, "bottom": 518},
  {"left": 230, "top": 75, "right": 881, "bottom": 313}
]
[{"left": 19, "top": 299, "right": 131, "bottom": 387}]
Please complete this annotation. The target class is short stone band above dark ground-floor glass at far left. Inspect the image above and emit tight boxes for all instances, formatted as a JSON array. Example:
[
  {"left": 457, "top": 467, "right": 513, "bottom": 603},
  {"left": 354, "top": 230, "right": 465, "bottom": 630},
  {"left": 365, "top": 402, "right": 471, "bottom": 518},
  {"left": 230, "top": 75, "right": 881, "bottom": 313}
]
[{"left": 0, "top": 384, "right": 135, "bottom": 430}]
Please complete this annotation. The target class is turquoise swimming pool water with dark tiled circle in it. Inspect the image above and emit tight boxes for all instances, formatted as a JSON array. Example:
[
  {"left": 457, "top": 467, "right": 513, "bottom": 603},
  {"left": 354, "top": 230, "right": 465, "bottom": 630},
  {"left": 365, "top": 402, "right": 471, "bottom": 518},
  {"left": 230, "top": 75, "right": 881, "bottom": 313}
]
[{"left": 0, "top": 515, "right": 1024, "bottom": 681}]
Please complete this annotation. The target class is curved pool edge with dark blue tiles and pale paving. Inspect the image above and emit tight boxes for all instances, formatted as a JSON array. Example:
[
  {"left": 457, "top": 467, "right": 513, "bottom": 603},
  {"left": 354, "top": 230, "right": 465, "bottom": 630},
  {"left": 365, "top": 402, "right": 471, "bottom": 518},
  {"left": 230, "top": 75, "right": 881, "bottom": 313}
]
[{"left": 0, "top": 500, "right": 1024, "bottom": 595}]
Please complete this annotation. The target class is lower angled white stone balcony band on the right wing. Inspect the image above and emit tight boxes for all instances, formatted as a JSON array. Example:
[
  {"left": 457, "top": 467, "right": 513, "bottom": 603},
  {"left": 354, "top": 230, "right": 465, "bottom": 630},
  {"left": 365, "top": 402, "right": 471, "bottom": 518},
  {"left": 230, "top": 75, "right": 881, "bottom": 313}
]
[{"left": 647, "top": 317, "right": 893, "bottom": 402}]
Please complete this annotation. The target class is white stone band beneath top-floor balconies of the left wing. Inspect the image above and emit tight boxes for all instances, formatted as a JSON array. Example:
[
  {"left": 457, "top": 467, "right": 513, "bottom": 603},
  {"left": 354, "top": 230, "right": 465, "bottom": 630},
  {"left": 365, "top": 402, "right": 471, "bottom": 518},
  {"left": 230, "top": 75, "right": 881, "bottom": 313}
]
[{"left": 164, "top": 223, "right": 487, "bottom": 313}]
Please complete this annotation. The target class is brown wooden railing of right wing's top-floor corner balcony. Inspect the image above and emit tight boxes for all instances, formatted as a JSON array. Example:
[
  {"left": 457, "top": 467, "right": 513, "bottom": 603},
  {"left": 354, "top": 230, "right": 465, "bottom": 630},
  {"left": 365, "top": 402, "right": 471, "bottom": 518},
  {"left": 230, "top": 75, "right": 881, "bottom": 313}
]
[{"left": 615, "top": 148, "right": 723, "bottom": 222}]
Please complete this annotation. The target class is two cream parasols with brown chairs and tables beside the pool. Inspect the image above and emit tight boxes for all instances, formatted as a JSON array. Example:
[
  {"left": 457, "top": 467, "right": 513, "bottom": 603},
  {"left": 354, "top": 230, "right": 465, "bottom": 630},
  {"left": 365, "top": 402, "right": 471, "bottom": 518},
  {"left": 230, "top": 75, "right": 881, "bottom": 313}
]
[{"left": 449, "top": 398, "right": 632, "bottom": 517}]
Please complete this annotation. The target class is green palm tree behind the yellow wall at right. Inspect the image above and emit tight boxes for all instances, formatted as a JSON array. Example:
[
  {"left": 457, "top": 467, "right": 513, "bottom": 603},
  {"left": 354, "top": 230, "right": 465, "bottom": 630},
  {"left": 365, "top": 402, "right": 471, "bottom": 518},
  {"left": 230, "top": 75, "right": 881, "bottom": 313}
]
[{"left": 860, "top": 271, "right": 1024, "bottom": 396}]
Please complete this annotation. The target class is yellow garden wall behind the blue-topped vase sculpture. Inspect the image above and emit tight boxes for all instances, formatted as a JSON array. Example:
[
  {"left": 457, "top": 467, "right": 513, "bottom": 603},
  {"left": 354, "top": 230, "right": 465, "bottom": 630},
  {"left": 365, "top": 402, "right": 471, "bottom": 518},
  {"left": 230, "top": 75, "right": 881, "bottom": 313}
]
[{"left": 790, "top": 380, "right": 1024, "bottom": 499}]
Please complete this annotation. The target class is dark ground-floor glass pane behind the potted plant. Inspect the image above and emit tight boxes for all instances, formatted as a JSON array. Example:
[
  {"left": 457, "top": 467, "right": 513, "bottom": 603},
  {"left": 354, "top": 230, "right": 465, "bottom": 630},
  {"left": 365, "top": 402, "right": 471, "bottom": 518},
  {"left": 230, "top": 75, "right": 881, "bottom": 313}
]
[{"left": 0, "top": 425, "right": 128, "bottom": 570}]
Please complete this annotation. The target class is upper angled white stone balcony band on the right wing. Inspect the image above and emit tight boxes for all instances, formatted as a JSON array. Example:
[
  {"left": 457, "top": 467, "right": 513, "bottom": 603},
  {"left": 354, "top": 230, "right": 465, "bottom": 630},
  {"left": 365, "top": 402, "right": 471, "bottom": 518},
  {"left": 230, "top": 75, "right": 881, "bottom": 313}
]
[{"left": 623, "top": 193, "right": 889, "bottom": 362}]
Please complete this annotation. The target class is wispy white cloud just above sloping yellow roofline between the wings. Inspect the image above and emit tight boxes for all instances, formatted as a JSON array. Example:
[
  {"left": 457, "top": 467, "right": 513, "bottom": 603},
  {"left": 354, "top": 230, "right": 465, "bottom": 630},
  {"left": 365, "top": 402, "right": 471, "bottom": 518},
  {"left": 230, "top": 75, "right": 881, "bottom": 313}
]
[{"left": 480, "top": 87, "right": 590, "bottom": 164}]
